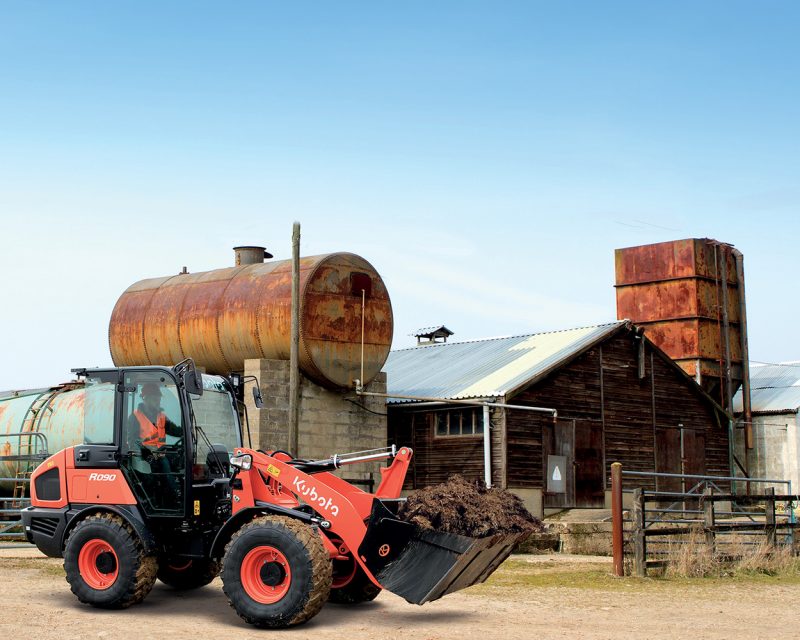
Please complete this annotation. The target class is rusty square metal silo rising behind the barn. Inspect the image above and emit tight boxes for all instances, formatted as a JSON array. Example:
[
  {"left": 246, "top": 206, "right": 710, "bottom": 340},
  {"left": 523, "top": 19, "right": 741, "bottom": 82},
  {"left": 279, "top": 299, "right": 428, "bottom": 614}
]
[{"left": 615, "top": 238, "right": 747, "bottom": 409}]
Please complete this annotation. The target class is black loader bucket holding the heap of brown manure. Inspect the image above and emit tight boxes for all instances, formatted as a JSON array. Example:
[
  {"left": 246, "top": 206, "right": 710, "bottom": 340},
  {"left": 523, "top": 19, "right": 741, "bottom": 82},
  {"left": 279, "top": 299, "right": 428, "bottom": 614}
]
[{"left": 359, "top": 500, "right": 528, "bottom": 604}]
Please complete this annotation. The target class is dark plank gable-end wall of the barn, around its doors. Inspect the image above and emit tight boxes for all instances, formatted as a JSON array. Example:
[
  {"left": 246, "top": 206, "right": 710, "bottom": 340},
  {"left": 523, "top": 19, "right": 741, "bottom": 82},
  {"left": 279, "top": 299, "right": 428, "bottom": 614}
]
[{"left": 507, "top": 332, "right": 729, "bottom": 488}]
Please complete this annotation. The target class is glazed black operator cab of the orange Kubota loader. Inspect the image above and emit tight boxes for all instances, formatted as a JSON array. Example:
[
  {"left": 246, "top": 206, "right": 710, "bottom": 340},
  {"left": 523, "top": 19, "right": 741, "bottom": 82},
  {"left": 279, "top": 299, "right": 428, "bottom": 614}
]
[{"left": 75, "top": 365, "right": 241, "bottom": 519}]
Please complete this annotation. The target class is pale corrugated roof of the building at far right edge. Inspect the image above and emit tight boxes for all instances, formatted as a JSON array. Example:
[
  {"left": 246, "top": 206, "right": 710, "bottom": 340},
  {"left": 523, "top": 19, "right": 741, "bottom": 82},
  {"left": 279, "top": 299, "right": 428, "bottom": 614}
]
[{"left": 733, "top": 362, "right": 800, "bottom": 413}]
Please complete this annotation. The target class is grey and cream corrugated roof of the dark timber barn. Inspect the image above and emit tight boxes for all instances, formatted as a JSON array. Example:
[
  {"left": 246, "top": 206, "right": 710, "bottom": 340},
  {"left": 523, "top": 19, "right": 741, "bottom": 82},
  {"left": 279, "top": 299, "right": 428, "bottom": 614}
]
[{"left": 383, "top": 320, "right": 625, "bottom": 402}]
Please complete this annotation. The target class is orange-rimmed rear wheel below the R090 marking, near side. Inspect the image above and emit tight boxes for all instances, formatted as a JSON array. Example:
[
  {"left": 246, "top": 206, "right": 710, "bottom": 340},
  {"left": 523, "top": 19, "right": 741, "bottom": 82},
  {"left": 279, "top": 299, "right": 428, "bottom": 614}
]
[{"left": 64, "top": 513, "right": 158, "bottom": 609}]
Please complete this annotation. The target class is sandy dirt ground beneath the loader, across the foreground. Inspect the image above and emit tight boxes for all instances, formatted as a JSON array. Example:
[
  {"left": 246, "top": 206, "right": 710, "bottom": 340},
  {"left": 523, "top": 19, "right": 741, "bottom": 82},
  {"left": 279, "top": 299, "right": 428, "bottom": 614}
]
[{"left": 0, "top": 548, "right": 800, "bottom": 640}]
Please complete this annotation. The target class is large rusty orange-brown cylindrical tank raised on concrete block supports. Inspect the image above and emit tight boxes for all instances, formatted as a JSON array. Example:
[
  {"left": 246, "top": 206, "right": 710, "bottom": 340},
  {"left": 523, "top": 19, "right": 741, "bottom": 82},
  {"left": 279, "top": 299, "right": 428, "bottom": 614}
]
[{"left": 109, "top": 253, "right": 393, "bottom": 388}]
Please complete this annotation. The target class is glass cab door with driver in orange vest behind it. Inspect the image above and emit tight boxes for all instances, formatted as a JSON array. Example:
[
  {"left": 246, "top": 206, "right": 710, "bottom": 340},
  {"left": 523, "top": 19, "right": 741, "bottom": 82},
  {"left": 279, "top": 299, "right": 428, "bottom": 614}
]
[{"left": 119, "top": 369, "right": 187, "bottom": 517}]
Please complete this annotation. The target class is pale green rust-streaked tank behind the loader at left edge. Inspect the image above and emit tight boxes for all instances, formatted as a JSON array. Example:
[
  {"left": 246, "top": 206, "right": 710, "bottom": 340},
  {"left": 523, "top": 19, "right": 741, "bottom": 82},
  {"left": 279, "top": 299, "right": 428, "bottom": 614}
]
[{"left": 0, "top": 383, "right": 94, "bottom": 494}]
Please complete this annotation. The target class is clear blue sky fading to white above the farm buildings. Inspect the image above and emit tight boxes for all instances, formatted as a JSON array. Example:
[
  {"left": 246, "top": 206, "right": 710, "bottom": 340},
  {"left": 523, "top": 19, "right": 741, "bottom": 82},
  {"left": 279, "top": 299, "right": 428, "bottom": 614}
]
[{"left": 0, "top": 1, "right": 800, "bottom": 389}]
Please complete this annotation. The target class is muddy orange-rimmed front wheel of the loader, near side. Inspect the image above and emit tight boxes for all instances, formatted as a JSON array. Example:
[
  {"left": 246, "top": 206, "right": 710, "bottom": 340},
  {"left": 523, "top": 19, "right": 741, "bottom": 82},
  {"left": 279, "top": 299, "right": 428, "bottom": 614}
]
[{"left": 222, "top": 516, "right": 332, "bottom": 628}]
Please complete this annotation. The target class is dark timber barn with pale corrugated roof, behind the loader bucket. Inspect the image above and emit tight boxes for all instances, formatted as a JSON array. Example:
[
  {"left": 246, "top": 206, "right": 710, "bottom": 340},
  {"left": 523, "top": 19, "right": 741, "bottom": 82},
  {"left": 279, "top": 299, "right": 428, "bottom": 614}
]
[{"left": 385, "top": 321, "right": 730, "bottom": 514}]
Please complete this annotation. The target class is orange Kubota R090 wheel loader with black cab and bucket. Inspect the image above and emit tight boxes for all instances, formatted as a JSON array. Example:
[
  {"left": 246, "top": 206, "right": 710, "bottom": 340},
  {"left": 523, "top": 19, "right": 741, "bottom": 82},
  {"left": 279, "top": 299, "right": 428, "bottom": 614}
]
[{"left": 23, "top": 361, "right": 519, "bottom": 628}]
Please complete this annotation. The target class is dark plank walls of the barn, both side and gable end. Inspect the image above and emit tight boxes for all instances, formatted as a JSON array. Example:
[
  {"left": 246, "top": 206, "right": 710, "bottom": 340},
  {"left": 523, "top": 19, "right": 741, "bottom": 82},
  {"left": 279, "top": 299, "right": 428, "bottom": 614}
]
[{"left": 389, "top": 332, "right": 729, "bottom": 489}]
